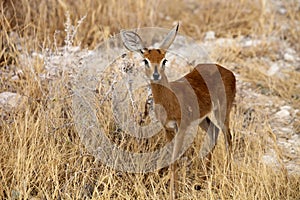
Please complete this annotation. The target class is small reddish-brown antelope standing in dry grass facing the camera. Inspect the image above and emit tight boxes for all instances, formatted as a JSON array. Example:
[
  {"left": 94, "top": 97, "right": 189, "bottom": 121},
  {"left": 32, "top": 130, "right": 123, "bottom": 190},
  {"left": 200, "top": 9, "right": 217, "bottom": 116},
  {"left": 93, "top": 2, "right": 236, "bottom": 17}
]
[{"left": 121, "top": 24, "right": 236, "bottom": 199}]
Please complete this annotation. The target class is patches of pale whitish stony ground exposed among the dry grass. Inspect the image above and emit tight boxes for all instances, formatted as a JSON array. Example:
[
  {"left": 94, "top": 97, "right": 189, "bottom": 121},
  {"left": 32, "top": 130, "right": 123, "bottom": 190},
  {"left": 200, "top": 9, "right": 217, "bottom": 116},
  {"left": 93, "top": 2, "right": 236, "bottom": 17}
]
[{"left": 0, "top": 0, "right": 300, "bottom": 174}]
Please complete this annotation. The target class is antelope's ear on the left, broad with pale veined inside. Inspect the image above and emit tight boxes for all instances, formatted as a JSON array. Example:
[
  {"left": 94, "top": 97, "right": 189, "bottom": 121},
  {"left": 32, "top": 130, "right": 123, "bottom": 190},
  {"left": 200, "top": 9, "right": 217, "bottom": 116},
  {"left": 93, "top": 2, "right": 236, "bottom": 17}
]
[{"left": 121, "top": 30, "right": 145, "bottom": 52}]
